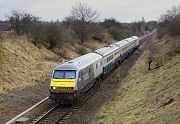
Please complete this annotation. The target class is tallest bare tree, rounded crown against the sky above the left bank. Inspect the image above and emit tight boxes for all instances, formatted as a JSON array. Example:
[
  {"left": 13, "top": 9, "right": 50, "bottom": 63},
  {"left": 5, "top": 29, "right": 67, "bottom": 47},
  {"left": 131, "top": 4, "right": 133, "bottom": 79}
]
[{"left": 68, "top": 3, "right": 99, "bottom": 43}]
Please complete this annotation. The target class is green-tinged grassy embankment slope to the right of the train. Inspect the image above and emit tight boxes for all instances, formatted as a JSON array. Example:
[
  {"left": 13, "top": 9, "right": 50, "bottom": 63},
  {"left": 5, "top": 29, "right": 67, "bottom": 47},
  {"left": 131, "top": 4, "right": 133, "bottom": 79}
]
[{"left": 93, "top": 37, "right": 180, "bottom": 124}]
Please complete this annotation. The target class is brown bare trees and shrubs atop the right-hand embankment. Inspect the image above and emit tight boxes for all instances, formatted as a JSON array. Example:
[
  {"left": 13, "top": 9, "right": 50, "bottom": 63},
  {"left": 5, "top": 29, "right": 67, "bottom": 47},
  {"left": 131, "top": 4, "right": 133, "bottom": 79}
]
[{"left": 147, "top": 6, "right": 180, "bottom": 70}]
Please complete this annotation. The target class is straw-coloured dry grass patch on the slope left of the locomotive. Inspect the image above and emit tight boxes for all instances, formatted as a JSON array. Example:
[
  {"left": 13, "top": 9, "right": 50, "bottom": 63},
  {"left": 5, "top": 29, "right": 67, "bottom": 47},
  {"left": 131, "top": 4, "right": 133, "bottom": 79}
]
[{"left": 0, "top": 37, "right": 58, "bottom": 95}]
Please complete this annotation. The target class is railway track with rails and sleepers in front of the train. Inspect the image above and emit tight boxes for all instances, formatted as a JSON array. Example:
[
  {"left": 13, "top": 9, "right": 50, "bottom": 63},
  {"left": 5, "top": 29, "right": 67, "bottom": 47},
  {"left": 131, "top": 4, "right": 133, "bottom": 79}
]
[{"left": 30, "top": 84, "right": 99, "bottom": 124}]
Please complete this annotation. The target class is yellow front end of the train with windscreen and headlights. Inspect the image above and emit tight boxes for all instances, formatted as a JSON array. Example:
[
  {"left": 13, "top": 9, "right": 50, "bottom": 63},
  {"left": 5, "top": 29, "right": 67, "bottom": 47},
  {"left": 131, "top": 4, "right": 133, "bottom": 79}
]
[{"left": 49, "top": 67, "right": 78, "bottom": 104}]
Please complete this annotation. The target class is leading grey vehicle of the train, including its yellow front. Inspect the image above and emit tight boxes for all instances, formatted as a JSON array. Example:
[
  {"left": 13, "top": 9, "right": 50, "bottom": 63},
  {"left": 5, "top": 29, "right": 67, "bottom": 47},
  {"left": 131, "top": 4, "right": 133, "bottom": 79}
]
[{"left": 50, "top": 53, "right": 103, "bottom": 103}]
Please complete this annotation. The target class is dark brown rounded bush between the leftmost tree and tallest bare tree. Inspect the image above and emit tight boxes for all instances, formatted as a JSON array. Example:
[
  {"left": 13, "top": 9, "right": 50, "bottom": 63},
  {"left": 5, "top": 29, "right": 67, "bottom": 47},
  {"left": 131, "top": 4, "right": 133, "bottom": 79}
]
[{"left": 30, "top": 22, "right": 61, "bottom": 50}]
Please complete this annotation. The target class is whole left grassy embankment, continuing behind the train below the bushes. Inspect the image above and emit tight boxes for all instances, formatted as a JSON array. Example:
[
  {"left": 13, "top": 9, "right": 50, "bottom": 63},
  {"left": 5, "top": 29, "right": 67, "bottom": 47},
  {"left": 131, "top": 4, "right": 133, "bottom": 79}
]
[{"left": 0, "top": 33, "right": 111, "bottom": 110}]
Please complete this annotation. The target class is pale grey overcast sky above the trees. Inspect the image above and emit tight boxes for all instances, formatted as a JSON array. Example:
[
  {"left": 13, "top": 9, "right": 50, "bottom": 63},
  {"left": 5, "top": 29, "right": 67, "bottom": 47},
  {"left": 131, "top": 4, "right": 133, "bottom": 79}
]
[{"left": 0, "top": 0, "right": 180, "bottom": 22}]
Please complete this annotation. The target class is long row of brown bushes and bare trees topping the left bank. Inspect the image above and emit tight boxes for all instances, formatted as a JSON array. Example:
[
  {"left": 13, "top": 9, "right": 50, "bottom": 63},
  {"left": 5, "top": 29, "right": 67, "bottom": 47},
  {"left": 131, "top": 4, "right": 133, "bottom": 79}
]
[{"left": 4, "top": 3, "right": 148, "bottom": 54}]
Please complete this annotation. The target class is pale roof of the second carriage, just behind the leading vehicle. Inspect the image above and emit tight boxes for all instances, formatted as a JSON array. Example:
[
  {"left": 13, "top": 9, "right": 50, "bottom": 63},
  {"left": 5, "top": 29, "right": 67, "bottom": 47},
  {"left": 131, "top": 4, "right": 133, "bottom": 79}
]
[{"left": 94, "top": 45, "right": 119, "bottom": 56}]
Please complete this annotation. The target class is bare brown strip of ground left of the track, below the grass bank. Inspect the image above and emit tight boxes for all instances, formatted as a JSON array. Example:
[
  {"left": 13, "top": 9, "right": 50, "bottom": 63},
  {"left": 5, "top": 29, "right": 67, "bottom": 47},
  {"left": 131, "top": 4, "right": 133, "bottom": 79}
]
[{"left": 0, "top": 81, "right": 49, "bottom": 124}]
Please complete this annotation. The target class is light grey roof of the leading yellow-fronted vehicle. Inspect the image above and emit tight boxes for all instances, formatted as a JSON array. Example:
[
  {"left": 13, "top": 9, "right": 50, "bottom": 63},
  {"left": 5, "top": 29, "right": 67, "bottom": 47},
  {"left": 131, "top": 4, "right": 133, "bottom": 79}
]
[{"left": 55, "top": 53, "right": 102, "bottom": 70}]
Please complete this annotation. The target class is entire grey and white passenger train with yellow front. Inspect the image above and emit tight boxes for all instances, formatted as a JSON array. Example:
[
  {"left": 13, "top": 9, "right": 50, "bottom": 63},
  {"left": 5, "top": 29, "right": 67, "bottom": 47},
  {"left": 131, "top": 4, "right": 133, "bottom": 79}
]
[{"left": 49, "top": 36, "right": 139, "bottom": 104}]
